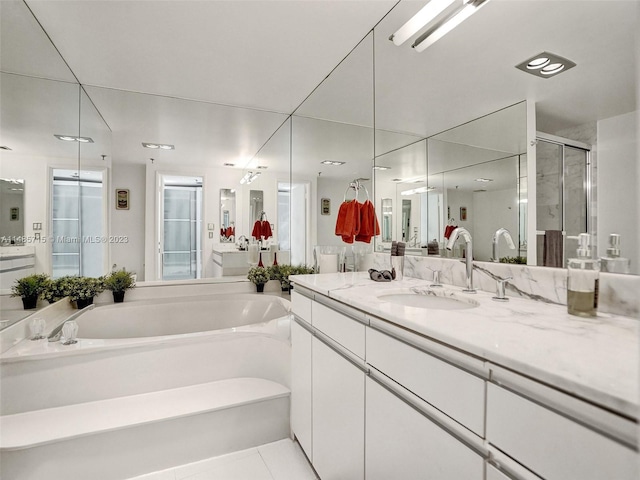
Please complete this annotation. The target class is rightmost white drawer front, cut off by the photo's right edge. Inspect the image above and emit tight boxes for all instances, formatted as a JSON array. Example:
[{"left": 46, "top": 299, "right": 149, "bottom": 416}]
[{"left": 487, "top": 384, "right": 638, "bottom": 480}]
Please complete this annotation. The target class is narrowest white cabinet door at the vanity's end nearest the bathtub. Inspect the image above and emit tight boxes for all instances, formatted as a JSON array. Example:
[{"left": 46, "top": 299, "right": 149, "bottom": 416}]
[{"left": 291, "top": 321, "right": 312, "bottom": 460}]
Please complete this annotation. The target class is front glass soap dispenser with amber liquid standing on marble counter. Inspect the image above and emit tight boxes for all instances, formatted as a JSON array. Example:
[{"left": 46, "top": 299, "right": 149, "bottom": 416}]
[{"left": 567, "top": 233, "right": 600, "bottom": 317}]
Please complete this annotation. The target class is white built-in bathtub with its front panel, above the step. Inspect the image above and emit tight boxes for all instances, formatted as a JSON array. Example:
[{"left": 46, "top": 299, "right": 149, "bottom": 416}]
[{"left": 0, "top": 293, "right": 291, "bottom": 415}]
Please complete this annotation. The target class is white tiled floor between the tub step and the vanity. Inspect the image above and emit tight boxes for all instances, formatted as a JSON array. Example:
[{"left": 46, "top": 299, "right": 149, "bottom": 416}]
[{"left": 130, "top": 439, "right": 317, "bottom": 480}]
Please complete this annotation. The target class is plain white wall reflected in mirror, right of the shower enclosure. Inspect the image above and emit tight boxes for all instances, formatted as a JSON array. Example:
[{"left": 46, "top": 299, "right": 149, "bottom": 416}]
[{"left": 597, "top": 112, "right": 640, "bottom": 274}]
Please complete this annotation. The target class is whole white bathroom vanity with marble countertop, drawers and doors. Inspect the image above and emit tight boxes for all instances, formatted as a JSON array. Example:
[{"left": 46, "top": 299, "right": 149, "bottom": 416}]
[{"left": 291, "top": 273, "right": 638, "bottom": 480}]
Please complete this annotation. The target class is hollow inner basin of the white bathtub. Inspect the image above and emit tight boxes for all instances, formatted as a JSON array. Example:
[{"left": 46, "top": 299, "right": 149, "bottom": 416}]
[{"left": 77, "top": 293, "right": 290, "bottom": 339}]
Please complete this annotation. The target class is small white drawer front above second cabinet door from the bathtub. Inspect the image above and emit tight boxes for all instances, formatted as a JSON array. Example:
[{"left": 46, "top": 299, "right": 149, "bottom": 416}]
[{"left": 311, "top": 302, "right": 366, "bottom": 358}]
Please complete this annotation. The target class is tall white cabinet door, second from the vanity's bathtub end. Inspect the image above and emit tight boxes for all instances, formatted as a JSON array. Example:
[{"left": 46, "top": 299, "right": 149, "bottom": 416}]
[{"left": 312, "top": 338, "right": 362, "bottom": 480}]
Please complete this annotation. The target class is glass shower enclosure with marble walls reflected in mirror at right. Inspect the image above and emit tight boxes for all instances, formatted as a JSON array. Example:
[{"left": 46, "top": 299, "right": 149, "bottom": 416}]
[{"left": 536, "top": 132, "right": 595, "bottom": 267}]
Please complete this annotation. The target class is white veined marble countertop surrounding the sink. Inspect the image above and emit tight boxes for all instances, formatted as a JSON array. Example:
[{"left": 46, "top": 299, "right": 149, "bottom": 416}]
[{"left": 291, "top": 272, "right": 640, "bottom": 418}]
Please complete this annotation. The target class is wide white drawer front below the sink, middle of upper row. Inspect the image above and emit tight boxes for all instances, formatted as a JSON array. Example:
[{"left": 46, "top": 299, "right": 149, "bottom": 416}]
[{"left": 366, "top": 328, "right": 485, "bottom": 437}]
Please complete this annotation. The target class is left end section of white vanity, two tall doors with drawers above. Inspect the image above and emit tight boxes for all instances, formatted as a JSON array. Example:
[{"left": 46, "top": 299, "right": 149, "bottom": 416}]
[{"left": 291, "top": 290, "right": 366, "bottom": 480}]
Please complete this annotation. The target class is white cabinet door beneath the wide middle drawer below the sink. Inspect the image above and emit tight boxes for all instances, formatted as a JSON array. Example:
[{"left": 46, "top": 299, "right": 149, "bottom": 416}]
[{"left": 365, "top": 378, "right": 484, "bottom": 480}]
